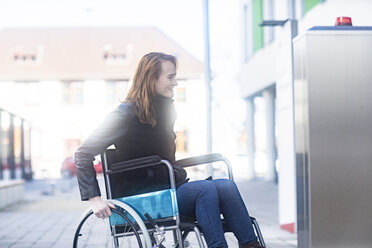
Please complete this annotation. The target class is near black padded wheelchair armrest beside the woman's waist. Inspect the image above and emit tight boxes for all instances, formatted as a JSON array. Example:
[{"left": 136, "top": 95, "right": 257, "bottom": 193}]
[{"left": 106, "top": 155, "right": 161, "bottom": 174}]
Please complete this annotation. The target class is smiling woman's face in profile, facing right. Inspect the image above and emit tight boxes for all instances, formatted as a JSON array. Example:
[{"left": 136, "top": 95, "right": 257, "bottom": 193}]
[{"left": 155, "top": 60, "right": 177, "bottom": 98}]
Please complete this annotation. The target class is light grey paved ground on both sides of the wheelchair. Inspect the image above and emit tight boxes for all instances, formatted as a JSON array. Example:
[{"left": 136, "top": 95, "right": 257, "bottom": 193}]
[{"left": 0, "top": 179, "right": 296, "bottom": 248}]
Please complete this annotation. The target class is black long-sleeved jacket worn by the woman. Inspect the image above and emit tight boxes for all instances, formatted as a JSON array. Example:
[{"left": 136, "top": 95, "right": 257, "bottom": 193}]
[{"left": 75, "top": 96, "right": 186, "bottom": 200}]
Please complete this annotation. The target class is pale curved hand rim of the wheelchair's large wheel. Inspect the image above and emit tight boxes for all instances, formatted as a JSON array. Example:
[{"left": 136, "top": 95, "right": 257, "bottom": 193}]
[{"left": 73, "top": 200, "right": 152, "bottom": 248}]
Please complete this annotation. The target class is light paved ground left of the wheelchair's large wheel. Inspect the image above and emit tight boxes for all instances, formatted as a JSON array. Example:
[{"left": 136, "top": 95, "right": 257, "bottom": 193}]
[{"left": 0, "top": 179, "right": 88, "bottom": 248}]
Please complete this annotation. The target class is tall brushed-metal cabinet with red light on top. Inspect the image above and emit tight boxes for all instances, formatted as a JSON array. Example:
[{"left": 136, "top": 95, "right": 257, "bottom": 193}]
[{"left": 293, "top": 26, "right": 372, "bottom": 248}]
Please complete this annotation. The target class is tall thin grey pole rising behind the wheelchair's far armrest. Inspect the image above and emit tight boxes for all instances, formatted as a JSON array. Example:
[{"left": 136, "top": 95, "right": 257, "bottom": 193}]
[{"left": 203, "top": 0, "right": 213, "bottom": 175}]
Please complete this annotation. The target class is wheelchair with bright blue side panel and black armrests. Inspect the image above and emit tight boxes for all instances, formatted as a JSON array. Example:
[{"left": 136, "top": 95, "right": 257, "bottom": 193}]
[{"left": 73, "top": 149, "right": 265, "bottom": 248}]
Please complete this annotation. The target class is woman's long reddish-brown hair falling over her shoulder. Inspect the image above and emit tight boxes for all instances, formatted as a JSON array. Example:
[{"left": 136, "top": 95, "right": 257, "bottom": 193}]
[{"left": 125, "top": 52, "right": 177, "bottom": 126}]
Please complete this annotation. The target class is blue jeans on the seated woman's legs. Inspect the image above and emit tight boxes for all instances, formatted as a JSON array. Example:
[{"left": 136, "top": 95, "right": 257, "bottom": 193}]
[{"left": 177, "top": 179, "right": 257, "bottom": 248}]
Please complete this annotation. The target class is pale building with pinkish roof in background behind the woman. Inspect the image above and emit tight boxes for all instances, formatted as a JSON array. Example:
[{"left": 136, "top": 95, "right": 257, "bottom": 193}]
[{"left": 0, "top": 27, "right": 205, "bottom": 177}]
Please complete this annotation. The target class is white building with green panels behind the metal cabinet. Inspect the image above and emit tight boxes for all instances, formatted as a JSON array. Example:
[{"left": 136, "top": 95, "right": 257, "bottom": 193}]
[{"left": 239, "top": 0, "right": 372, "bottom": 232}]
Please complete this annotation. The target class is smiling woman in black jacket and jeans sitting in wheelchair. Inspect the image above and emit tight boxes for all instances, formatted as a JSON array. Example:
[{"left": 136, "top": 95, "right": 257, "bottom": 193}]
[{"left": 75, "top": 52, "right": 261, "bottom": 248}]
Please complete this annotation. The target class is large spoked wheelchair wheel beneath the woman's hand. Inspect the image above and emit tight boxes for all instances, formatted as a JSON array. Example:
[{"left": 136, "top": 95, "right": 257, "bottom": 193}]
[{"left": 73, "top": 209, "right": 146, "bottom": 248}]
